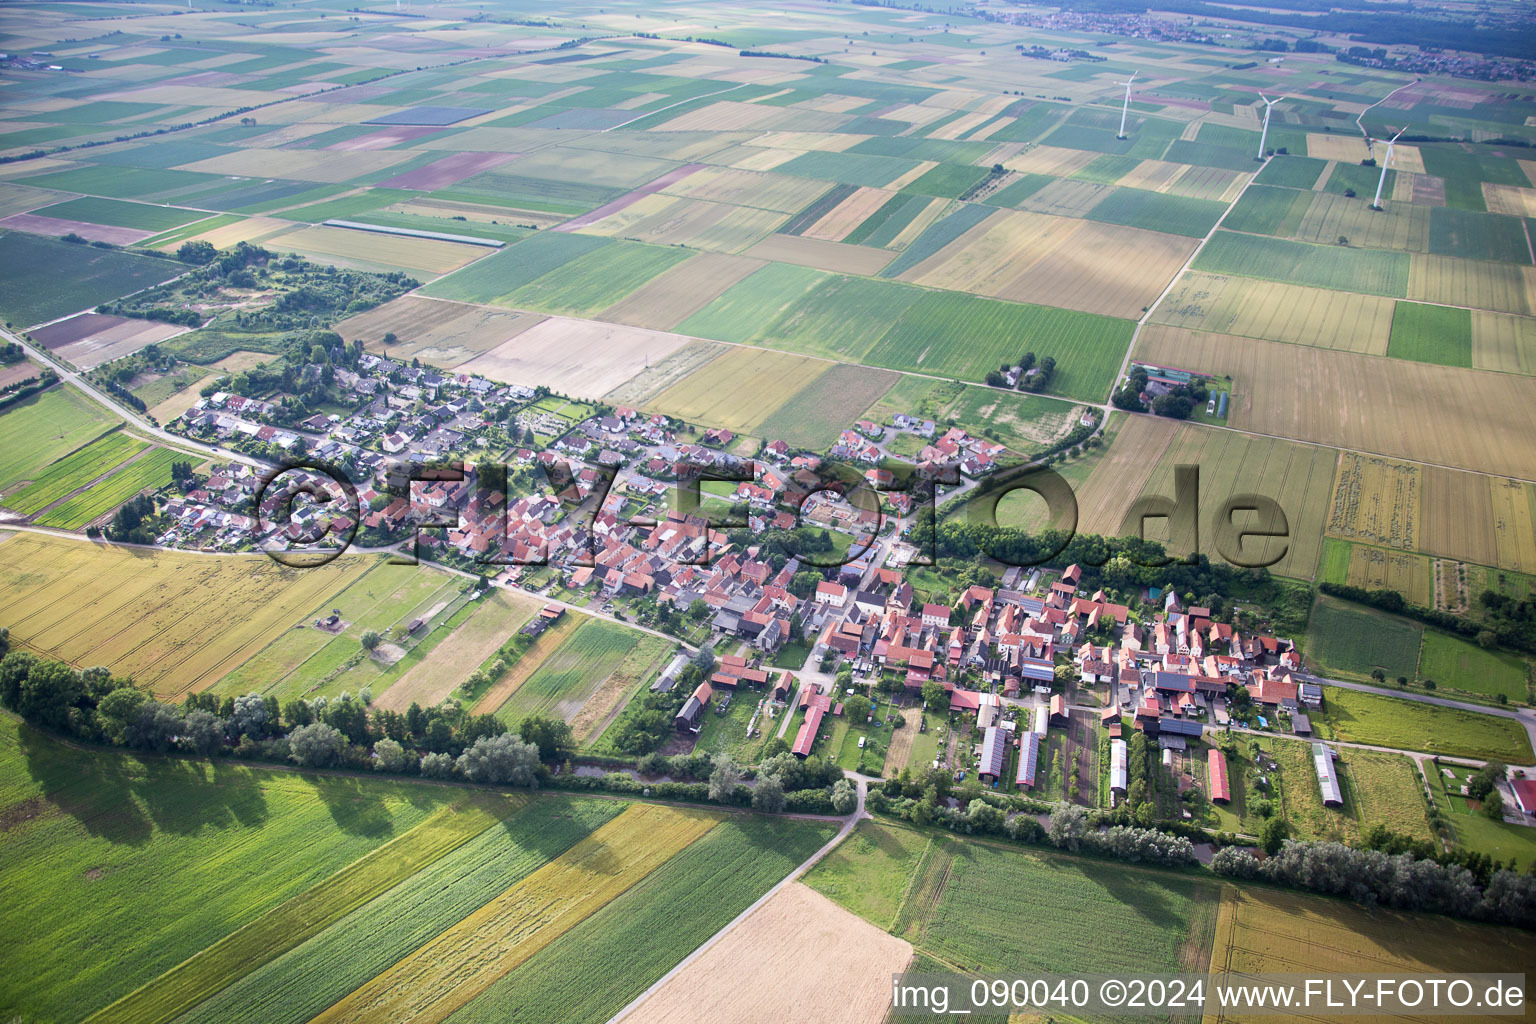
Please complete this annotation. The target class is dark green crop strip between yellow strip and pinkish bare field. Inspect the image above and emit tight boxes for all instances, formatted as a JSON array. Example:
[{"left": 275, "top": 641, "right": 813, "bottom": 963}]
[{"left": 439, "top": 817, "right": 836, "bottom": 1024}]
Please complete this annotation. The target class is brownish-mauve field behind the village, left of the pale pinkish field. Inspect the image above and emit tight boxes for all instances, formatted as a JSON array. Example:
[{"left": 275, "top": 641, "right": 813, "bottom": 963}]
[{"left": 335, "top": 295, "right": 547, "bottom": 370}]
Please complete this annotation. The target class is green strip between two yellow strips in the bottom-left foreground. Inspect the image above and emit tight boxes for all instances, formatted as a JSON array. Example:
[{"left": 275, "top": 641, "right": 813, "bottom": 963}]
[{"left": 168, "top": 795, "right": 625, "bottom": 1024}]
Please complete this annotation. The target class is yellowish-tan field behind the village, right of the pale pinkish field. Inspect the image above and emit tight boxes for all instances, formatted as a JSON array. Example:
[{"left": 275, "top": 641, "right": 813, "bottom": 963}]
[{"left": 647, "top": 345, "right": 833, "bottom": 433}]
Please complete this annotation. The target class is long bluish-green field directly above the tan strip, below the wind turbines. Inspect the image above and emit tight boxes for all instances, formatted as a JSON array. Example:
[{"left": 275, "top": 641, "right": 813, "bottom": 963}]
[{"left": 1193, "top": 230, "right": 1409, "bottom": 298}]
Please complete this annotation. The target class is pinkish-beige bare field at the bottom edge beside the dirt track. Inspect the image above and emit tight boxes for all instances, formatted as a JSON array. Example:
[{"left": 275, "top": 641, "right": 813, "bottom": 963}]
[{"left": 625, "top": 881, "right": 912, "bottom": 1024}]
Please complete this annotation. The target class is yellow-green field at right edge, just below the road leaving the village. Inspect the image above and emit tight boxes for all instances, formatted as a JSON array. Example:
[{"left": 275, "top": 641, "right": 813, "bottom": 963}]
[{"left": 1312, "top": 686, "right": 1536, "bottom": 765}]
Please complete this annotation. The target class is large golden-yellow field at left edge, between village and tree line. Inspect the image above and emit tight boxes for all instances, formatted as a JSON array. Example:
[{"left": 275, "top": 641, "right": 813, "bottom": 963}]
[{"left": 0, "top": 534, "right": 375, "bottom": 697}]
